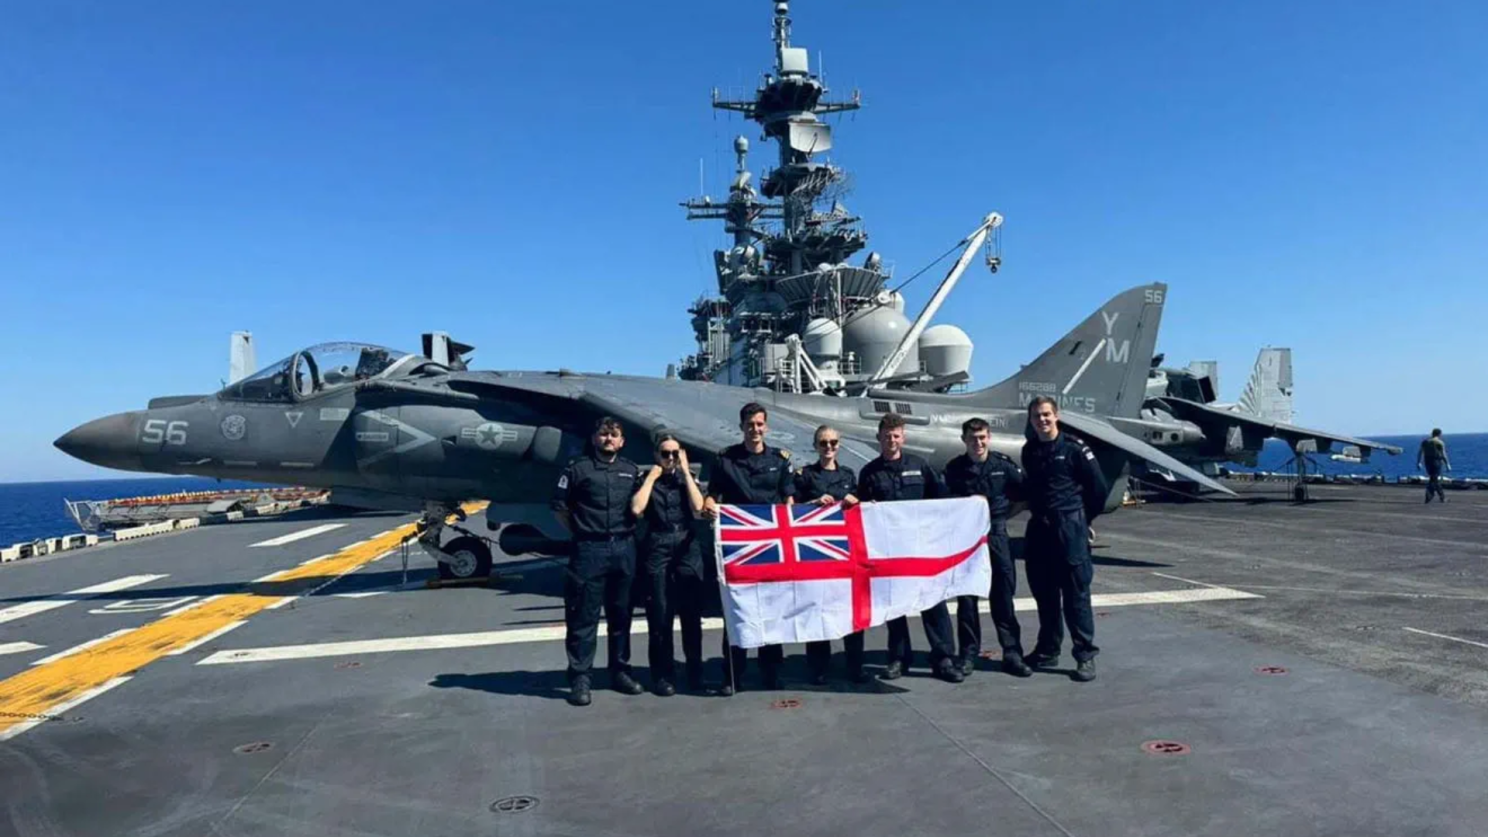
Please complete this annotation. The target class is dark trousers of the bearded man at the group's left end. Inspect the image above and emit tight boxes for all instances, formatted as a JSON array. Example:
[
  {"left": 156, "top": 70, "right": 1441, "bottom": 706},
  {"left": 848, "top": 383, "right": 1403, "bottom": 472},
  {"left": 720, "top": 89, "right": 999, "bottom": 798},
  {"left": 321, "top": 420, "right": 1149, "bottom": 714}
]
[{"left": 564, "top": 536, "right": 635, "bottom": 682}]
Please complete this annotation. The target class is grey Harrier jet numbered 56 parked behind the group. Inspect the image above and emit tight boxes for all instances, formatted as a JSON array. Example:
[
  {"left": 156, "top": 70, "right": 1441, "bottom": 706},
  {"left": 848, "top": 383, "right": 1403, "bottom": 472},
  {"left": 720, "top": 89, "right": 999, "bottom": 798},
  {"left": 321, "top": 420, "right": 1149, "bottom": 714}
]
[{"left": 55, "top": 284, "right": 1226, "bottom": 578}]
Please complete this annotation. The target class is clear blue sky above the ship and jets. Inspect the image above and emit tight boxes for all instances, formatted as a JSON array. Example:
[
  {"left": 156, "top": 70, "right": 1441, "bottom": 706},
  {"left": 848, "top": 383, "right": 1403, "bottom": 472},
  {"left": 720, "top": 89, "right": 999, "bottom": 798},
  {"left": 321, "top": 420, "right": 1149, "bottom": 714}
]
[{"left": 0, "top": 0, "right": 1488, "bottom": 481}]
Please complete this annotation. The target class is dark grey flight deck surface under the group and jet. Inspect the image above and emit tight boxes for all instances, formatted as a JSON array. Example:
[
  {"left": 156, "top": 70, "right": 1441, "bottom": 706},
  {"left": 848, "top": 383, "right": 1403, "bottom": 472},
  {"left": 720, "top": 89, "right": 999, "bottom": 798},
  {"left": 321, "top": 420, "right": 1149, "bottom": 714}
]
[{"left": 0, "top": 486, "right": 1488, "bottom": 837}]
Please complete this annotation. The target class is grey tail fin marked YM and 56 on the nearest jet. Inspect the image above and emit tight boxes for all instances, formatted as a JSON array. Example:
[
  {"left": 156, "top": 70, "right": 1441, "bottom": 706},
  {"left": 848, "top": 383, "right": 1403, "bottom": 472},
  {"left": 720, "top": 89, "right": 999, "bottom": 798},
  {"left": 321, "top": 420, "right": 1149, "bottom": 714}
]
[{"left": 966, "top": 283, "right": 1168, "bottom": 417}]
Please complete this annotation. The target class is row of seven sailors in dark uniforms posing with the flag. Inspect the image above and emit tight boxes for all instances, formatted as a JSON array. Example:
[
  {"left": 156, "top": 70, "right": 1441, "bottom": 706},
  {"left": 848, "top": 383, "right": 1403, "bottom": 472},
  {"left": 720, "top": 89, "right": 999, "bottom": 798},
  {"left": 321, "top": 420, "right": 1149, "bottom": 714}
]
[{"left": 552, "top": 398, "right": 1107, "bottom": 706}]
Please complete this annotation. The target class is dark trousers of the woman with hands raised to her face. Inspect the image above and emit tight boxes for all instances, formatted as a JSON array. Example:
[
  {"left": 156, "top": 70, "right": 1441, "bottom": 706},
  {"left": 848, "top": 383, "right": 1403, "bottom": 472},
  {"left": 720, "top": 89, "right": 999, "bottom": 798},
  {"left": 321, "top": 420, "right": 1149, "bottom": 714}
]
[{"left": 644, "top": 535, "right": 707, "bottom": 681}]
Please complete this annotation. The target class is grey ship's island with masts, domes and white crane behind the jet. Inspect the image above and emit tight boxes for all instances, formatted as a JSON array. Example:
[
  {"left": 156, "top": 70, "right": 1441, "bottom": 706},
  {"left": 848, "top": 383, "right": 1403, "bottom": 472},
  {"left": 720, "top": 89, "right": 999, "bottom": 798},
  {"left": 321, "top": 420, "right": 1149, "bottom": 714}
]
[{"left": 679, "top": 1, "right": 1001, "bottom": 395}]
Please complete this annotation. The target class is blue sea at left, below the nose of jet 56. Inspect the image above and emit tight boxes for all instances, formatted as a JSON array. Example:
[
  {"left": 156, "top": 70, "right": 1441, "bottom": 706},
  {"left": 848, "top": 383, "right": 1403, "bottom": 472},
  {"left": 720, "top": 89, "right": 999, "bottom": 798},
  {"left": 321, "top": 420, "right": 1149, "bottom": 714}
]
[{"left": 0, "top": 477, "right": 279, "bottom": 547}]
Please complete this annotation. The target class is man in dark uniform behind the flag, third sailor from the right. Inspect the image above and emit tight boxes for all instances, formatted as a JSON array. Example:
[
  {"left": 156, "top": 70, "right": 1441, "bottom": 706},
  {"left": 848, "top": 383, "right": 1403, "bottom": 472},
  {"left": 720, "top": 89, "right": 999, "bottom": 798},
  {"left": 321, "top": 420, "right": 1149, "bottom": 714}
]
[{"left": 857, "top": 413, "right": 966, "bottom": 684}]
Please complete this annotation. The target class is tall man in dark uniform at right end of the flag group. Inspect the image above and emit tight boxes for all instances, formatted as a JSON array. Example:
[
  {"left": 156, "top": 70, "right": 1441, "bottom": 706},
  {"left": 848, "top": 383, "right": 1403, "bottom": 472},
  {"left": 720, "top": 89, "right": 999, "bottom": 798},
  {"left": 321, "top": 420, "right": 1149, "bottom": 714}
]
[{"left": 1022, "top": 395, "right": 1109, "bottom": 682}]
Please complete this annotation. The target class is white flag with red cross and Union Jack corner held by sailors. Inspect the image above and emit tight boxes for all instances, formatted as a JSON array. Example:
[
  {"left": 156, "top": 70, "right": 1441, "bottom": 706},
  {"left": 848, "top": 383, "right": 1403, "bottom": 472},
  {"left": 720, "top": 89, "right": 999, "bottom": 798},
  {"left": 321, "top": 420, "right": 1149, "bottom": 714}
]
[{"left": 713, "top": 497, "right": 992, "bottom": 648}]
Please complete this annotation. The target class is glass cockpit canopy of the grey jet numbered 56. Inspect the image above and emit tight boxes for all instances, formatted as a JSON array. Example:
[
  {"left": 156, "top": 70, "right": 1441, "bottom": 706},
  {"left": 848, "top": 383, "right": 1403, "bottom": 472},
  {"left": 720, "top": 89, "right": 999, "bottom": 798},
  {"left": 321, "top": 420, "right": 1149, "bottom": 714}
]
[{"left": 217, "top": 343, "right": 414, "bottom": 401}]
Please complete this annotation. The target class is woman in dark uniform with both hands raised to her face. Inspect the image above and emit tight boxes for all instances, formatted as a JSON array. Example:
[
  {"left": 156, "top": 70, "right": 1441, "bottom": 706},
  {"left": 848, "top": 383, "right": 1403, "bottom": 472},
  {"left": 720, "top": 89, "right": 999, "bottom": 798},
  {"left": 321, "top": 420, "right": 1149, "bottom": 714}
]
[{"left": 631, "top": 433, "right": 704, "bottom": 697}]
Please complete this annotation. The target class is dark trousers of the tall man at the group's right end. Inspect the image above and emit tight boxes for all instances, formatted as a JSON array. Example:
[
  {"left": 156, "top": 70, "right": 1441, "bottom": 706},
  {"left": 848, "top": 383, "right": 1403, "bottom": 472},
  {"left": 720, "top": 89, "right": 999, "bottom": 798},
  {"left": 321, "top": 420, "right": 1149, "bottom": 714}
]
[{"left": 1024, "top": 511, "right": 1101, "bottom": 661}]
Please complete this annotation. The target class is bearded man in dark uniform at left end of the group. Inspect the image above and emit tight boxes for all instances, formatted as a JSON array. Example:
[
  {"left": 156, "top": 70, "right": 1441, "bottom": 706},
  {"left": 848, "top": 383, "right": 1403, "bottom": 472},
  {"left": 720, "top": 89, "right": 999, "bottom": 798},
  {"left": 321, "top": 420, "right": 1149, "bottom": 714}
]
[{"left": 552, "top": 416, "right": 643, "bottom": 706}]
